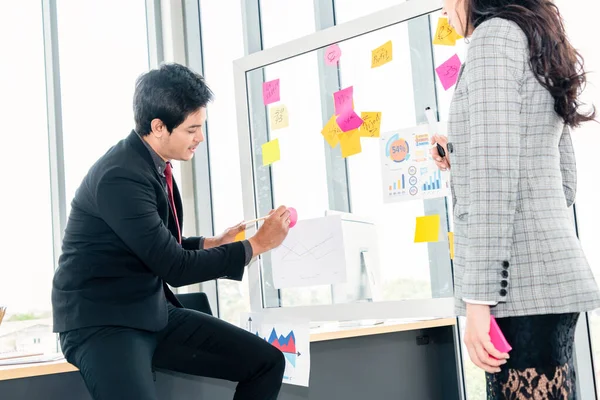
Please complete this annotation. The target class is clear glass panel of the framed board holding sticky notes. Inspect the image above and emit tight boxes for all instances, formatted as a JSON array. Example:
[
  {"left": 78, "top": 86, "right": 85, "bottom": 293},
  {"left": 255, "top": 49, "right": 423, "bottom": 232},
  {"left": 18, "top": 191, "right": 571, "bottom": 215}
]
[{"left": 238, "top": 7, "right": 464, "bottom": 307}]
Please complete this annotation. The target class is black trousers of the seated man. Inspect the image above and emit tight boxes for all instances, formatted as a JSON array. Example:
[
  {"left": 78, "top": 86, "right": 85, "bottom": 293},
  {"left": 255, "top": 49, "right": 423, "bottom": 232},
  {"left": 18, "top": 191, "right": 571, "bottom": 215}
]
[{"left": 60, "top": 305, "right": 285, "bottom": 400}]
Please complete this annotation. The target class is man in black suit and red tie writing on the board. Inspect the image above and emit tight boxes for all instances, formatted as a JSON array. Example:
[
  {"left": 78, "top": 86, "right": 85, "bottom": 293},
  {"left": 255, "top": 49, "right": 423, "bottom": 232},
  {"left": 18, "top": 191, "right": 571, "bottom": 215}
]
[{"left": 52, "top": 64, "right": 290, "bottom": 400}]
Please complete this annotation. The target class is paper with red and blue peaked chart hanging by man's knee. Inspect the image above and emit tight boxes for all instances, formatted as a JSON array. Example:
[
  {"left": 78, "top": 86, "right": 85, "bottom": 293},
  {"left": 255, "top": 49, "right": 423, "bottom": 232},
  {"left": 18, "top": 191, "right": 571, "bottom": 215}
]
[{"left": 240, "top": 313, "right": 310, "bottom": 386}]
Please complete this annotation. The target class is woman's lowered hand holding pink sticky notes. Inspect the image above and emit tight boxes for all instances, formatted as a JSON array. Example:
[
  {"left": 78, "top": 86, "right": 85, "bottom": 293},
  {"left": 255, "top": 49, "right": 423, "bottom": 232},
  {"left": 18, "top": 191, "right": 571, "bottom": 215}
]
[{"left": 465, "top": 303, "right": 508, "bottom": 374}]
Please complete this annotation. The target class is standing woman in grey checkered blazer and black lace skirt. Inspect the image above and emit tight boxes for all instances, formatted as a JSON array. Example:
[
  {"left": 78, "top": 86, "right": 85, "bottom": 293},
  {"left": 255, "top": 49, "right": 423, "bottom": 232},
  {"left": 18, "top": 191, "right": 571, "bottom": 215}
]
[{"left": 432, "top": 0, "right": 600, "bottom": 399}]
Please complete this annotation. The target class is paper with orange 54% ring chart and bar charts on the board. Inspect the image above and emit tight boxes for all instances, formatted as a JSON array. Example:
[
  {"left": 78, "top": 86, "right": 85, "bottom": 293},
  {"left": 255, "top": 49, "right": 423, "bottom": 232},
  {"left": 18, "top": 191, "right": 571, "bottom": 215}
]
[{"left": 380, "top": 123, "right": 450, "bottom": 203}]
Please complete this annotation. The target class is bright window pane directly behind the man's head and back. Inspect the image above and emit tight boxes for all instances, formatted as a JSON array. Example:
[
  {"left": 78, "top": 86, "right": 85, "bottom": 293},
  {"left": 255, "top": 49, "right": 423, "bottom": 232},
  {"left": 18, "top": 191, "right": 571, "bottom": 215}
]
[{"left": 57, "top": 0, "right": 150, "bottom": 209}]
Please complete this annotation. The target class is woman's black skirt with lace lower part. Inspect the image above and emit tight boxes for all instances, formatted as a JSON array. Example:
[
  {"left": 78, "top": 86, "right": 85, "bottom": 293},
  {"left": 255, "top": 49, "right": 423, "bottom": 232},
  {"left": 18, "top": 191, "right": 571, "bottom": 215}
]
[{"left": 486, "top": 313, "right": 579, "bottom": 400}]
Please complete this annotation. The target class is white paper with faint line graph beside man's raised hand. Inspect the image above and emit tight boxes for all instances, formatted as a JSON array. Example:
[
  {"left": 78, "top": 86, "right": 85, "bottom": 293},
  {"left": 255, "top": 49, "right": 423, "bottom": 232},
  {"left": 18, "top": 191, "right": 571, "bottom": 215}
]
[{"left": 271, "top": 215, "right": 346, "bottom": 289}]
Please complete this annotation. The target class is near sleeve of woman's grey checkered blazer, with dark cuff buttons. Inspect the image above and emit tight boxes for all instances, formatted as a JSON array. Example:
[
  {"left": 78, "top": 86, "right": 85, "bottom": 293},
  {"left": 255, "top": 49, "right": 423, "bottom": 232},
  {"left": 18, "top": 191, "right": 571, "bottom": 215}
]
[{"left": 462, "top": 20, "right": 528, "bottom": 302}]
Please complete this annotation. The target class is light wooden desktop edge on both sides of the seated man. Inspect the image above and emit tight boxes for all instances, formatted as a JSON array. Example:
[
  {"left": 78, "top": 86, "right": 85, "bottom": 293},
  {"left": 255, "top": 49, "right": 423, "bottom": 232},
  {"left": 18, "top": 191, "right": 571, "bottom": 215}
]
[{"left": 0, "top": 318, "right": 456, "bottom": 381}]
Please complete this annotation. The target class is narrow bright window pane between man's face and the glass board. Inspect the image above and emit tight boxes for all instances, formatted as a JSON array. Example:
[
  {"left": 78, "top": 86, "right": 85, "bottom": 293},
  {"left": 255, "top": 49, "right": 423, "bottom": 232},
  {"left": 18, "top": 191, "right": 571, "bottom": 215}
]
[{"left": 200, "top": 1, "right": 250, "bottom": 324}]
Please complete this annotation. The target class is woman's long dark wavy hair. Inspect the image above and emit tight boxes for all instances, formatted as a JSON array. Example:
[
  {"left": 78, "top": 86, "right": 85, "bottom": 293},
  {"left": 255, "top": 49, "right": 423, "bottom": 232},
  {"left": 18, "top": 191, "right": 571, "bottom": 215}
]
[{"left": 465, "top": 0, "right": 596, "bottom": 127}]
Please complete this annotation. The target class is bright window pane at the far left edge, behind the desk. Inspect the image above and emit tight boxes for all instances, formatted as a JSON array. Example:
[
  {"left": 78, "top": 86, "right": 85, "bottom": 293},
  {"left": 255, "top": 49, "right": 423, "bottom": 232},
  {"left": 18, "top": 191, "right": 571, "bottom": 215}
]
[{"left": 0, "top": 1, "right": 56, "bottom": 353}]
